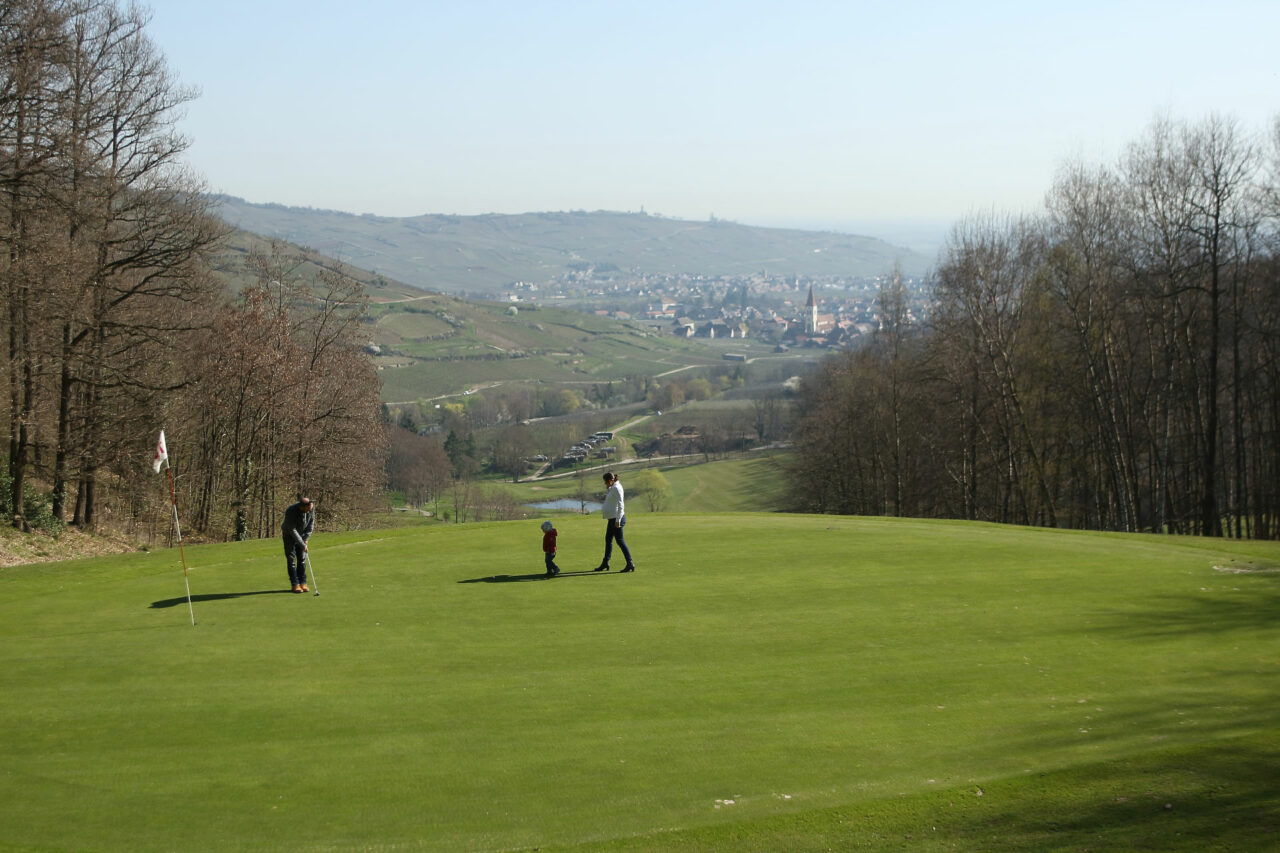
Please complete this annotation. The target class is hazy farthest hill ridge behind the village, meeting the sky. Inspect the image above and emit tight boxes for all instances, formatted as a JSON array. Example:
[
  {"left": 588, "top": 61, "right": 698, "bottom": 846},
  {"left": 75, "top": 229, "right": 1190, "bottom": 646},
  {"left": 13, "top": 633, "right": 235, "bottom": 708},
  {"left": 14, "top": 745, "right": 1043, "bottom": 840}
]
[{"left": 216, "top": 196, "right": 929, "bottom": 295}]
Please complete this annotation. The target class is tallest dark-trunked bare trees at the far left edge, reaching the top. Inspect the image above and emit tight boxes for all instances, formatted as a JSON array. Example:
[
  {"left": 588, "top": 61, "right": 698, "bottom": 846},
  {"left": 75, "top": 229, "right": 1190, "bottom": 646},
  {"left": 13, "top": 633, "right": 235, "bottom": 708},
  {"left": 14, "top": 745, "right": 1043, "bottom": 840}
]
[{"left": 0, "top": 0, "right": 221, "bottom": 526}]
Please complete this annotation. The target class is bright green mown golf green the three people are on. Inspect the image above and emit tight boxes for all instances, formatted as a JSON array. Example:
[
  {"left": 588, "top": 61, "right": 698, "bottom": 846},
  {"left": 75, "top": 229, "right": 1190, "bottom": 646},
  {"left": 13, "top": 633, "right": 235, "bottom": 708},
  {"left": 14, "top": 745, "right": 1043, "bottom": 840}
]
[{"left": 0, "top": 514, "right": 1280, "bottom": 850}]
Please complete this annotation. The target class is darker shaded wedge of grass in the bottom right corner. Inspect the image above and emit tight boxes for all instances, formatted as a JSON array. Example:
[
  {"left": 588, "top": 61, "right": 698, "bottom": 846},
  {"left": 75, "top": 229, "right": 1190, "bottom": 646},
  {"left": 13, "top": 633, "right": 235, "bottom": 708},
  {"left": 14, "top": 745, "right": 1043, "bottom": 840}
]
[{"left": 550, "top": 729, "right": 1280, "bottom": 853}]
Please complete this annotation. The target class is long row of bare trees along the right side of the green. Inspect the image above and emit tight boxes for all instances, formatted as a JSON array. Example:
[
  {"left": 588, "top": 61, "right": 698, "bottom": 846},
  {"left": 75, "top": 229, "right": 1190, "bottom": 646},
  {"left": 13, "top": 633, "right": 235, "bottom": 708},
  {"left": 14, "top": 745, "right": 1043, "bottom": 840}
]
[{"left": 791, "top": 115, "right": 1280, "bottom": 538}]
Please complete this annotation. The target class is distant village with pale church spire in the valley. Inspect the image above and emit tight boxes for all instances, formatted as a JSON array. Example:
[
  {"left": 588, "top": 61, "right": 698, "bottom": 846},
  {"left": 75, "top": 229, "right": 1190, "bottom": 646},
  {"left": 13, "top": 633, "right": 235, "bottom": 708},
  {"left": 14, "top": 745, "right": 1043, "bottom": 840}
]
[{"left": 500, "top": 269, "right": 932, "bottom": 348}]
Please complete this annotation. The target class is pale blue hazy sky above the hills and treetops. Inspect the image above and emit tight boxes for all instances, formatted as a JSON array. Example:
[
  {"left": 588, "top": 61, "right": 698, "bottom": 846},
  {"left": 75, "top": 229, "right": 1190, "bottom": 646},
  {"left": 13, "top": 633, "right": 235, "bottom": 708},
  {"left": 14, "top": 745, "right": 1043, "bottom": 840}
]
[{"left": 147, "top": 0, "right": 1280, "bottom": 245}]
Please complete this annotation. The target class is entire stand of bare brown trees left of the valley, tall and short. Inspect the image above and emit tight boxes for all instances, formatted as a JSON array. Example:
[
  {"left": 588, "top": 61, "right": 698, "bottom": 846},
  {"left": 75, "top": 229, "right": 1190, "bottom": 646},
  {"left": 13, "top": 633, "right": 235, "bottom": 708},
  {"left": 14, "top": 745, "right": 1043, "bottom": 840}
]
[{"left": 0, "top": 0, "right": 383, "bottom": 537}]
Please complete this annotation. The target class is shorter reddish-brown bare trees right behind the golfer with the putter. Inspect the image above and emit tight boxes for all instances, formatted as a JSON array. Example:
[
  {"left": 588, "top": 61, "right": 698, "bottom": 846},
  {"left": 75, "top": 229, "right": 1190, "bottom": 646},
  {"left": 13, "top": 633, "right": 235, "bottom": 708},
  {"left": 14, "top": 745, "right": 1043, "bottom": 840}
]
[{"left": 177, "top": 242, "right": 387, "bottom": 538}]
